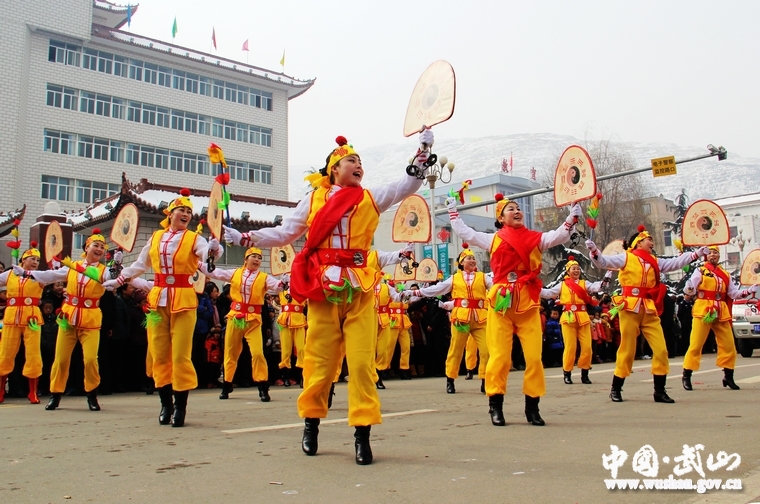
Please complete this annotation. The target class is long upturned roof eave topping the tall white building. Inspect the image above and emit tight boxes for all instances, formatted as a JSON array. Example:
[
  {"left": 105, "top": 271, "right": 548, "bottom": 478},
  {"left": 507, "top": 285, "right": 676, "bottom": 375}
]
[{"left": 92, "top": 23, "right": 316, "bottom": 100}]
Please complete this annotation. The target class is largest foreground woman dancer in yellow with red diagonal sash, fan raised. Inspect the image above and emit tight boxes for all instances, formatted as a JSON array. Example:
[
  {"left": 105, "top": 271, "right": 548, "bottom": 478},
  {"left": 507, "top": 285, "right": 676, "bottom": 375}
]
[{"left": 225, "top": 130, "right": 433, "bottom": 465}]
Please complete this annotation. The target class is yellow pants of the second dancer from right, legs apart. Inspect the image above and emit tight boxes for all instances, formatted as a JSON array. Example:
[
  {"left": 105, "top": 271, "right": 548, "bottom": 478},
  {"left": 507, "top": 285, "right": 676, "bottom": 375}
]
[{"left": 615, "top": 307, "right": 670, "bottom": 378}]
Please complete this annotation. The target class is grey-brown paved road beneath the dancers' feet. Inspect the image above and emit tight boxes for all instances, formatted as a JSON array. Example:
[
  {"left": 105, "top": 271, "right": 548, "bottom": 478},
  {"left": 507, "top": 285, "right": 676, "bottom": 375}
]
[{"left": 0, "top": 356, "right": 760, "bottom": 504}]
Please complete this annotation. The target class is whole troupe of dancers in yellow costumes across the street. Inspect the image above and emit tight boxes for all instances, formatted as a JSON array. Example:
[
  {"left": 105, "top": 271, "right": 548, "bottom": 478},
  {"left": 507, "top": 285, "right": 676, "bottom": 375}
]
[{"left": 0, "top": 129, "right": 756, "bottom": 465}]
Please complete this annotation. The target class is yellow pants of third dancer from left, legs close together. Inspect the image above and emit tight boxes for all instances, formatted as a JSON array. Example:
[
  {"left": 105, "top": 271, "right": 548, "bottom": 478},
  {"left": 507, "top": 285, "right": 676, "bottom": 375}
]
[{"left": 148, "top": 306, "right": 198, "bottom": 392}]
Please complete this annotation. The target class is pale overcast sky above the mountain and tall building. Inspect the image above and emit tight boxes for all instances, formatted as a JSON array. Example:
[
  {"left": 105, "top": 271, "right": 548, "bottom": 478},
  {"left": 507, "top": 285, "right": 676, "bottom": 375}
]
[{"left": 126, "top": 0, "right": 760, "bottom": 166}]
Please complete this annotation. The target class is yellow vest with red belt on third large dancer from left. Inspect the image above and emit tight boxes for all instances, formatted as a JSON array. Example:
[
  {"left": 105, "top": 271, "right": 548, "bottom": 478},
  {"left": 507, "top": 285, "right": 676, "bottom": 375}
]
[{"left": 148, "top": 229, "right": 200, "bottom": 313}]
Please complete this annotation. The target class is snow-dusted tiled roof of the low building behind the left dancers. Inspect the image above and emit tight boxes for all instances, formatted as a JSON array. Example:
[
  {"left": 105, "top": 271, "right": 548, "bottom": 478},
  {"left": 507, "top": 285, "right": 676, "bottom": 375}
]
[{"left": 63, "top": 173, "right": 297, "bottom": 233}]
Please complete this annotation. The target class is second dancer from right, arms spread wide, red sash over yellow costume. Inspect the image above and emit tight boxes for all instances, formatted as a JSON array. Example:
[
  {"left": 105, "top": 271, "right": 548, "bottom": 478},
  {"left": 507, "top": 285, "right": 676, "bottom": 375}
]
[{"left": 586, "top": 226, "right": 707, "bottom": 403}]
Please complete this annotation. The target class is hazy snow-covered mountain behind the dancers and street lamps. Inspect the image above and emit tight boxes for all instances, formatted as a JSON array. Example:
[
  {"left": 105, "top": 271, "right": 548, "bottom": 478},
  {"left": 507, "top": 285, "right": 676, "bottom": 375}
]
[{"left": 289, "top": 133, "right": 760, "bottom": 206}]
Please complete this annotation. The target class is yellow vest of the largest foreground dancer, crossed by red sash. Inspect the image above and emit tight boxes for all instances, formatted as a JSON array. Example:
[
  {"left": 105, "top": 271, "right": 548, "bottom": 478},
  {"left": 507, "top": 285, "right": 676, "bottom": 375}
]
[{"left": 306, "top": 187, "right": 382, "bottom": 292}]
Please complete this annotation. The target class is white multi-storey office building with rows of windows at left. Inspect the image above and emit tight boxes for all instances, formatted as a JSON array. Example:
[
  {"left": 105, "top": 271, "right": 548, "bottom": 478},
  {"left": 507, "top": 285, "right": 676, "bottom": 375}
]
[{"left": 0, "top": 0, "right": 314, "bottom": 262}]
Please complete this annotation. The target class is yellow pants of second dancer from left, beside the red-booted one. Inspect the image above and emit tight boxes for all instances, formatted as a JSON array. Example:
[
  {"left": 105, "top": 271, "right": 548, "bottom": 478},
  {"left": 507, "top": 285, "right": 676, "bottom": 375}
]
[{"left": 50, "top": 327, "right": 100, "bottom": 394}]
